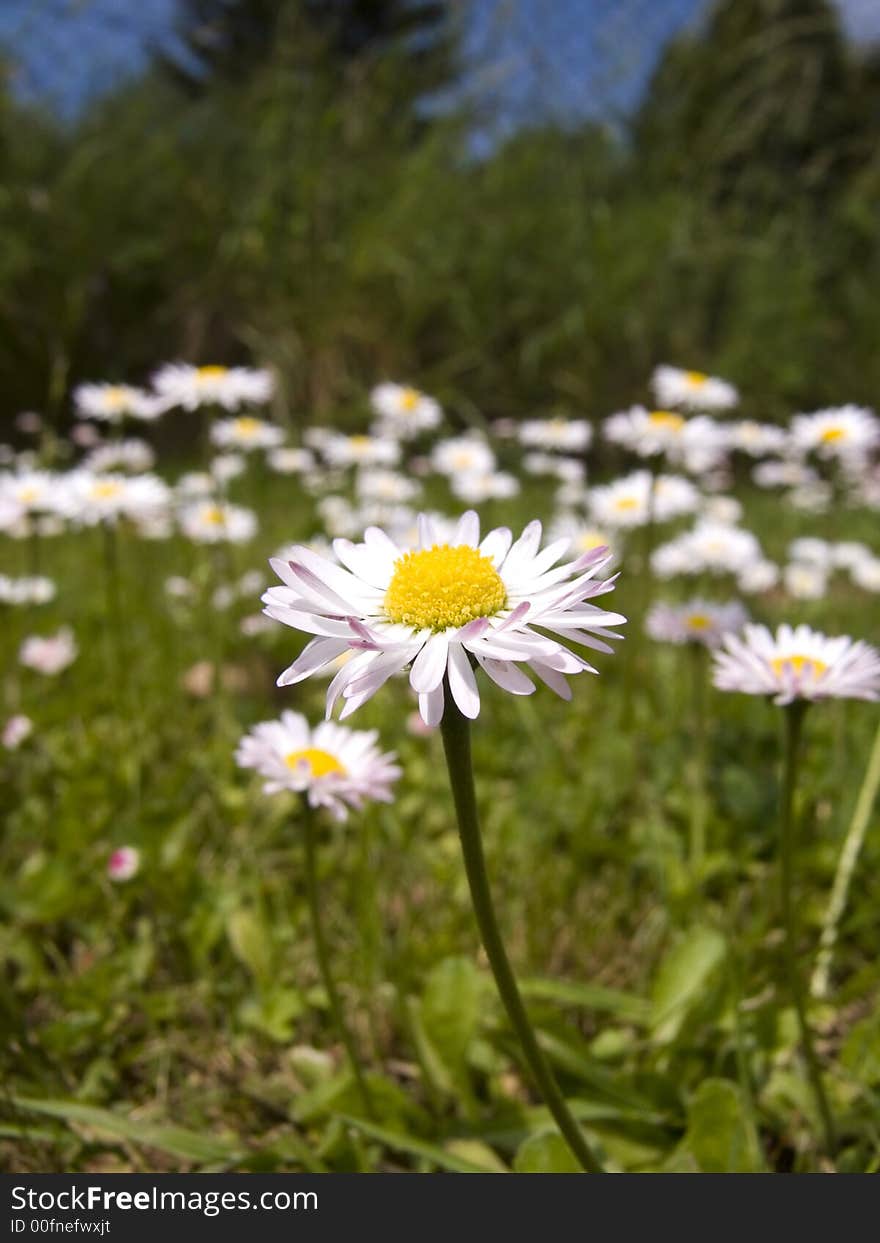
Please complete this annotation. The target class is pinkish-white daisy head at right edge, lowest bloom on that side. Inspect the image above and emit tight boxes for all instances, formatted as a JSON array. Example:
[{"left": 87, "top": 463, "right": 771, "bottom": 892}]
[{"left": 713, "top": 625, "right": 880, "bottom": 705}]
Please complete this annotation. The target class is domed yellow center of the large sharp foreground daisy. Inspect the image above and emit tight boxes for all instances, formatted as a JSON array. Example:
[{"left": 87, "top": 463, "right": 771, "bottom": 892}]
[{"left": 385, "top": 544, "right": 507, "bottom": 631}]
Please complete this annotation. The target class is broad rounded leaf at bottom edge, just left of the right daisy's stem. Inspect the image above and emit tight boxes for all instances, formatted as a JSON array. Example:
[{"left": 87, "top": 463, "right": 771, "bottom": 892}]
[{"left": 681, "top": 1079, "right": 764, "bottom": 1173}]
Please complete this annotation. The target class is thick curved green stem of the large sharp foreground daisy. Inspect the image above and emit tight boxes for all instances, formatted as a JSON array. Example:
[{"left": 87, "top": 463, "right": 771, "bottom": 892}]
[{"left": 441, "top": 687, "right": 603, "bottom": 1173}]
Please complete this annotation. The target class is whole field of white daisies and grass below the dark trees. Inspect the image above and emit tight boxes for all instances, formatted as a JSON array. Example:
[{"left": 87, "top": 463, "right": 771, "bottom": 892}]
[{"left": 0, "top": 363, "right": 880, "bottom": 1173}]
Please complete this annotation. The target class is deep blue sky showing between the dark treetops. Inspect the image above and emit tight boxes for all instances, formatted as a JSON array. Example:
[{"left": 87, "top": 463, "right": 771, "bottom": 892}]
[{"left": 0, "top": 0, "right": 880, "bottom": 119}]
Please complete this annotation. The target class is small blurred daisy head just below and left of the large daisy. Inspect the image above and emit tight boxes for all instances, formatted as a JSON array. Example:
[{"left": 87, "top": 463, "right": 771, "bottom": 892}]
[{"left": 235, "top": 711, "right": 400, "bottom": 820}]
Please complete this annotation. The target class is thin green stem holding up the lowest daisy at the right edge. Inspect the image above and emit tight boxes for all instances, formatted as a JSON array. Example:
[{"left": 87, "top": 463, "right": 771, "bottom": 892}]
[{"left": 779, "top": 701, "right": 836, "bottom": 1157}]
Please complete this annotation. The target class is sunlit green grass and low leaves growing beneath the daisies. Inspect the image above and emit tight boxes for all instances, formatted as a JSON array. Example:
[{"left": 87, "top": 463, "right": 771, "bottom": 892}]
[{"left": 0, "top": 462, "right": 880, "bottom": 1171}]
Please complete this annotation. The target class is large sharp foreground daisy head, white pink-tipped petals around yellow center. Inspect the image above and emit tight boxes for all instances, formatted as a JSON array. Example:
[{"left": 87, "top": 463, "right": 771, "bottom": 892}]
[{"left": 262, "top": 511, "right": 625, "bottom": 725}]
